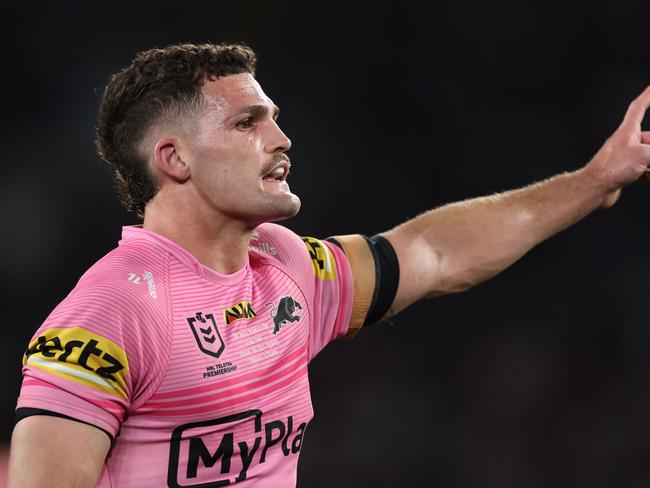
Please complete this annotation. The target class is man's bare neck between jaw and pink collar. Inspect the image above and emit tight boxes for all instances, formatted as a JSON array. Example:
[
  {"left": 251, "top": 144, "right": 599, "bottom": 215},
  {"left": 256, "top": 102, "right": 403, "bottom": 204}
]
[{"left": 142, "top": 196, "right": 253, "bottom": 274}]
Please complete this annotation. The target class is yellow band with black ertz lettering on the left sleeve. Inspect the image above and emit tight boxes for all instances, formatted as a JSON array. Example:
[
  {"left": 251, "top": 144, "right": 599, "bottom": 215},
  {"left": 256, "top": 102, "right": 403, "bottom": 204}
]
[{"left": 23, "top": 327, "right": 129, "bottom": 398}]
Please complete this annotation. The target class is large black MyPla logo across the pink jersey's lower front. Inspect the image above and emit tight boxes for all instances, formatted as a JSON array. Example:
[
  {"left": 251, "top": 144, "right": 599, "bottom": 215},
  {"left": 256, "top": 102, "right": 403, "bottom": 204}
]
[{"left": 167, "top": 410, "right": 307, "bottom": 488}]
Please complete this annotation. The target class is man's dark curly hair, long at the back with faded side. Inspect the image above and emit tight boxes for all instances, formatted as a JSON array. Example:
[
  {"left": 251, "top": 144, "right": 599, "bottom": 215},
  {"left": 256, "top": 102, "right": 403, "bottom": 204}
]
[{"left": 96, "top": 44, "right": 256, "bottom": 217}]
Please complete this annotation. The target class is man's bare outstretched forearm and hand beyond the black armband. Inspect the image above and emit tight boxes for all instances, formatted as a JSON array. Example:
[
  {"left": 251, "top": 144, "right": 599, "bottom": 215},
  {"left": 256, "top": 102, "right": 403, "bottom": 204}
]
[{"left": 383, "top": 87, "right": 650, "bottom": 315}]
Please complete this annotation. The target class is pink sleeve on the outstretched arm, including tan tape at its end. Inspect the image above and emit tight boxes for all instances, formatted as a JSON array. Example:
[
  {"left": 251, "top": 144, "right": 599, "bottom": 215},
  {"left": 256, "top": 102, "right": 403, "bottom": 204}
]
[{"left": 256, "top": 224, "right": 375, "bottom": 360}]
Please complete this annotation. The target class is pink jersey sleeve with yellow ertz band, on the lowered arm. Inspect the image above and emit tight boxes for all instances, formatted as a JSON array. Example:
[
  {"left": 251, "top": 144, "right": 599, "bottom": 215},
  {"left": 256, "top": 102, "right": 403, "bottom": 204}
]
[{"left": 16, "top": 250, "right": 168, "bottom": 440}]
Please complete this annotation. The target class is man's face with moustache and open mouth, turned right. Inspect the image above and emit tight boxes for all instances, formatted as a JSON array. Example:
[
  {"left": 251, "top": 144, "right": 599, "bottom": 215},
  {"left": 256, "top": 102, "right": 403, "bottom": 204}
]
[{"left": 185, "top": 73, "right": 300, "bottom": 226}]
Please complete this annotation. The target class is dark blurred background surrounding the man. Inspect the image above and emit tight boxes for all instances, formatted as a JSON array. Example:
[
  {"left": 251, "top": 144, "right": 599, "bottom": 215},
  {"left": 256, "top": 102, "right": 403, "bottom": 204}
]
[{"left": 0, "top": 0, "right": 650, "bottom": 488}]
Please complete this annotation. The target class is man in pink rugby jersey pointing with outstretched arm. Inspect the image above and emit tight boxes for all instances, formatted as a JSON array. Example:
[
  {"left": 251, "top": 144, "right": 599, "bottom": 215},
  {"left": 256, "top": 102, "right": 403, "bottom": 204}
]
[{"left": 9, "top": 45, "right": 650, "bottom": 487}]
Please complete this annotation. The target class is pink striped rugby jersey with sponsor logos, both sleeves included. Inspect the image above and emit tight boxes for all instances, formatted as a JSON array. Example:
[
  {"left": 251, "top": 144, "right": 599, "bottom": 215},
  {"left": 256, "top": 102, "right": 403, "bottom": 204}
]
[{"left": 18, "top": 224, "right": 354, "bottom": 488}]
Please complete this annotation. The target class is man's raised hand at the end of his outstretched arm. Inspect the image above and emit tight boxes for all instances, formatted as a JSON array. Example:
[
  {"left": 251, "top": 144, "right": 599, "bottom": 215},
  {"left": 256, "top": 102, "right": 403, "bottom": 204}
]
[{"left": 585, "top": 86, "right": 650, "bottom": 208}]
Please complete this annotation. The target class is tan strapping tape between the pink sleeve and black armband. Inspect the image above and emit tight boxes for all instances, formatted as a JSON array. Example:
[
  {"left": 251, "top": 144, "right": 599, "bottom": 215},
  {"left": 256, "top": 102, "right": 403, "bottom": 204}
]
[{"left": 333, "top": 234, "right": 377, "bottom": 337}]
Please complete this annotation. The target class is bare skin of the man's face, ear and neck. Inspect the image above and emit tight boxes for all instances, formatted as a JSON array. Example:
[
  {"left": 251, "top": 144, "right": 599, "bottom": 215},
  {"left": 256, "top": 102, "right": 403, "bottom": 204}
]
[{"left": 143, "top": 73, "right": 300, "bottom": 274}]
